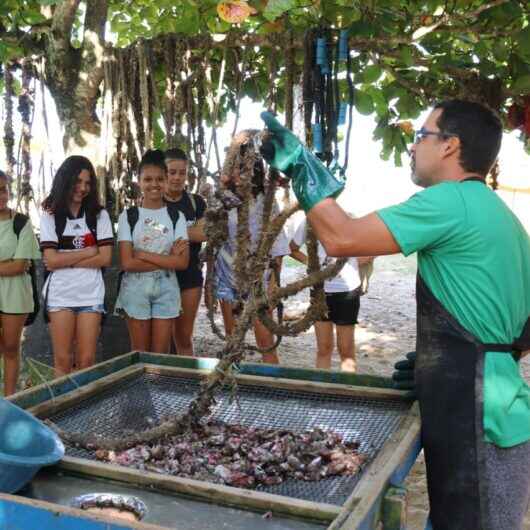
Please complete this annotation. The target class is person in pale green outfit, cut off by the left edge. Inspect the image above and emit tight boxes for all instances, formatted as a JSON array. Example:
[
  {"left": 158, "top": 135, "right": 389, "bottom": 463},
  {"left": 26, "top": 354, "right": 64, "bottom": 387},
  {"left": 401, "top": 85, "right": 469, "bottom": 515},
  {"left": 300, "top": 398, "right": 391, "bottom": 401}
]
[{"left": 0, "top": 171, "right": 40, "bottom": 396}]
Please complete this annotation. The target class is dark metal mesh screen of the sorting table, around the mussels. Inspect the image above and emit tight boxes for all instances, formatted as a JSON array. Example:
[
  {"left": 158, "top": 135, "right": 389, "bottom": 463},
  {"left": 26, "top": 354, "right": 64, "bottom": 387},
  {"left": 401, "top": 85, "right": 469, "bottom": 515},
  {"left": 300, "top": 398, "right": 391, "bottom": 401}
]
[{"left": 46, "top": 373, "right": 409, "bottom": 505}]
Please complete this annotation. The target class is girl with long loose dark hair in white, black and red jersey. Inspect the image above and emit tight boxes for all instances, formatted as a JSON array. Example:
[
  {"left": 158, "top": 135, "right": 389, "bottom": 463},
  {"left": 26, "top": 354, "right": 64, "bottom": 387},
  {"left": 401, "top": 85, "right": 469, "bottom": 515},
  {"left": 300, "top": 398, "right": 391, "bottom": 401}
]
[{"left": 40, "top": 156, "right": 114, "bottom": 375}]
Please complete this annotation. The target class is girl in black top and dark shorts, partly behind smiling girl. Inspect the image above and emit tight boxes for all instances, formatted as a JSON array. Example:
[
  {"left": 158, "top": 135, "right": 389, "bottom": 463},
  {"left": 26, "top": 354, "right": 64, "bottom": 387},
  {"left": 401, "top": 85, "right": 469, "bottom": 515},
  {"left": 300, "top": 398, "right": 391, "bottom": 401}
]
[{"left": 164, "top": 149, "right": 206, "bottom": 355}]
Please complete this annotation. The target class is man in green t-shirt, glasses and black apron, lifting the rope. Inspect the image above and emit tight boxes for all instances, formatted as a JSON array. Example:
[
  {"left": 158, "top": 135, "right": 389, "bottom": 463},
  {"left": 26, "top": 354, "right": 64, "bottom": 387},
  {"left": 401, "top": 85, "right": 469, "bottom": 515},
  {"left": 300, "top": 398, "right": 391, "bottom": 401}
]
[{"left": 262, "top": 100, "right": 530, "bottom": 530}]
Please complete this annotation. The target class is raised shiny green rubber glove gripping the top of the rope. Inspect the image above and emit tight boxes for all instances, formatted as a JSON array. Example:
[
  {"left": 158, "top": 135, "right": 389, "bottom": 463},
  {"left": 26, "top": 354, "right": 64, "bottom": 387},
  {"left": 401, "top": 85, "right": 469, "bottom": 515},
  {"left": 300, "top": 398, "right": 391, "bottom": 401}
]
[{"left": 261, "top": 112, "right": 345, "bottom": 212}]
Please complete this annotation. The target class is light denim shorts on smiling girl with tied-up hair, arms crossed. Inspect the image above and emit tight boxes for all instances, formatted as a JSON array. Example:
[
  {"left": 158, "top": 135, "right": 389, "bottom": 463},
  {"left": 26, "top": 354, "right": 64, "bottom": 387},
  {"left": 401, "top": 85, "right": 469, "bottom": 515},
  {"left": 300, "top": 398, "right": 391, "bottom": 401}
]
[{"left": 115, "top": 271, "right": 181, "bottom": 320}]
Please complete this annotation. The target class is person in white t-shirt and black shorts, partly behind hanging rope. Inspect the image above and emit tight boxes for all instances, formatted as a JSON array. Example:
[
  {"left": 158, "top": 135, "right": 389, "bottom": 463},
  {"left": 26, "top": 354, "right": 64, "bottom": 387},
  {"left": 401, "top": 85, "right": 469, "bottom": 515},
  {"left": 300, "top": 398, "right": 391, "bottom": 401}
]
[{"left": 290, "top": 219, "right": 372, "bottom": 372}]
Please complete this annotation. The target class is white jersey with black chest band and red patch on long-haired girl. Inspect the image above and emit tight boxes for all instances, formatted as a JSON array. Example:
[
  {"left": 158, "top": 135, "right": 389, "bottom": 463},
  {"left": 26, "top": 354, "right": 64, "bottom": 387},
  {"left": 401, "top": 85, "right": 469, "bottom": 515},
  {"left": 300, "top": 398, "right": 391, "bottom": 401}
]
[{"left": 40, "top": 210, "right": 114, "bottom": 307}]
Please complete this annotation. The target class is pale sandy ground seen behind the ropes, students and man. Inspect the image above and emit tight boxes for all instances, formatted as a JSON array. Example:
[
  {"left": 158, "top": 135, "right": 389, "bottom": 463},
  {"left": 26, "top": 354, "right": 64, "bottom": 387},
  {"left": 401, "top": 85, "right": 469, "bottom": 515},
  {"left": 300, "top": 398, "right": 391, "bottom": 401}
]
[{"left": 195, "top": 256, "right": 530, "bottom": 530}]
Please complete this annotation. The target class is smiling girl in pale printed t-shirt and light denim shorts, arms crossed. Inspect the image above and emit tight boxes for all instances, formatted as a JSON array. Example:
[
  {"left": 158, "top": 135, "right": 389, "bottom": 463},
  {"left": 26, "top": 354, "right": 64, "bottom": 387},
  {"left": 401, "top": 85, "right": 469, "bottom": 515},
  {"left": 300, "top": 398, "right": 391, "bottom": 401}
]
[{"left": 116, "top": 150, "right": 189, "bottom": 353}]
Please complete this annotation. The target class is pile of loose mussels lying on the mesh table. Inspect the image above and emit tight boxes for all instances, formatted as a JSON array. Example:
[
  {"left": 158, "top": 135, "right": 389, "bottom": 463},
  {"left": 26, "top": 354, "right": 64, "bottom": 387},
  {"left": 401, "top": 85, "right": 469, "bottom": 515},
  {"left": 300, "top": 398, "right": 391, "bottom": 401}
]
[{"left": 96, "top": 421, "right": 366, "bottom": 488}]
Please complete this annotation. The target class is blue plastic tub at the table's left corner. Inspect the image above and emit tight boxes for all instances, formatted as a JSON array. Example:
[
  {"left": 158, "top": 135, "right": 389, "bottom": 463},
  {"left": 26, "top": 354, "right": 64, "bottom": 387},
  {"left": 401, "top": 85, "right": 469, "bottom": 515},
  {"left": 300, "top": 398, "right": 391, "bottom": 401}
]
[{"left": 0, "top": 399, "right": 64, "bottom": 493}]
